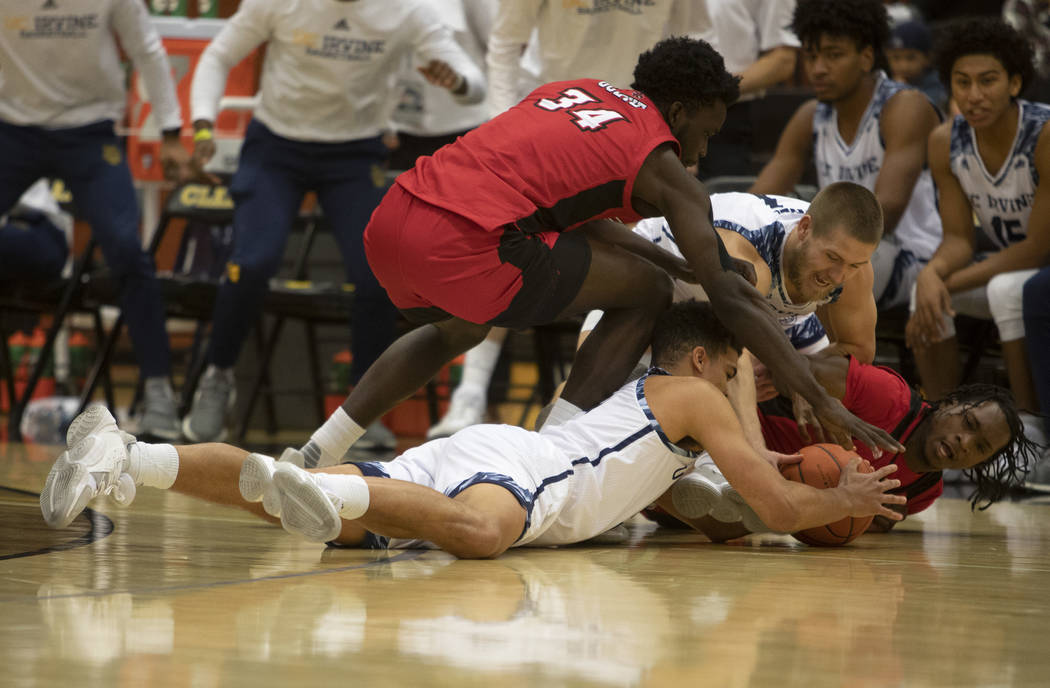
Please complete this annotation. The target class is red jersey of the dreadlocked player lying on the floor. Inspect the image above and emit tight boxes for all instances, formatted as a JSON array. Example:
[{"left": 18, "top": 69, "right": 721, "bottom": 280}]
[{"left": 758, "top": 357, "right": 944, "bottom": 514}]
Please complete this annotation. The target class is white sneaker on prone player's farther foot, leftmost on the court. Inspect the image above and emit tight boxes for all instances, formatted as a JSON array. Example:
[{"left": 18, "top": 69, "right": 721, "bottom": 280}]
[{"left": 40, "top": 430, "right": 135, "bottom": 528}]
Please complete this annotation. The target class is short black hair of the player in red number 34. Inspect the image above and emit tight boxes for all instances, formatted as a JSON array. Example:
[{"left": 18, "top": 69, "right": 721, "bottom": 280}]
[{"left": 631, "top": 36, "right": 740, "bottom": 109}]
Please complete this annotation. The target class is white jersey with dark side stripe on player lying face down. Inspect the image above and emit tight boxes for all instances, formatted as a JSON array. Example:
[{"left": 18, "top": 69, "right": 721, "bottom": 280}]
[{"left": 518, "top": 374, "right": 696, "bottom": 545}]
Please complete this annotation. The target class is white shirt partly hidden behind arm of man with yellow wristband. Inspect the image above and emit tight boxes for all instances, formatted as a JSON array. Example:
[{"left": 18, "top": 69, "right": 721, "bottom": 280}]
[{"left": 393, "top": 0, "right": 499, "bottom": 137}]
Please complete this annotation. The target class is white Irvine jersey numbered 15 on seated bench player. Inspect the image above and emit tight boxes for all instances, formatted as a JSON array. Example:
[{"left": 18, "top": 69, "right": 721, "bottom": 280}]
[{"left": 949, "top": 100, "right": 1050, "bottom": 249}]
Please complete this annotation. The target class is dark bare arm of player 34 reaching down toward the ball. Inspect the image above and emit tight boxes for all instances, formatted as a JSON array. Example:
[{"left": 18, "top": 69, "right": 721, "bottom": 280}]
[{"left": 634, "top": 146, "right": 903, "bottom": 453}]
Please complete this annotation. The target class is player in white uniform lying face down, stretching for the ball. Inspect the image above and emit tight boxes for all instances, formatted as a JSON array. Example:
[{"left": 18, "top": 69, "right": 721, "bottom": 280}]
[{"left": 40, "top": 301, "right": 905, "bottom": 558}]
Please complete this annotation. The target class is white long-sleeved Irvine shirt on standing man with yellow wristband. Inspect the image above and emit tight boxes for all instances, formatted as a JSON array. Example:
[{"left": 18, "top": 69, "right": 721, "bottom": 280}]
[{"left": 190, "top": 0, "right": 485, "bottom": 142}]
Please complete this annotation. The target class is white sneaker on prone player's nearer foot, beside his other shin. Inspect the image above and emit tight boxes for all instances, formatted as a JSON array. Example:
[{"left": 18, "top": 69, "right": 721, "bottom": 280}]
[{"left": 273, "top": 463, "right": 342, "bottom": 542}]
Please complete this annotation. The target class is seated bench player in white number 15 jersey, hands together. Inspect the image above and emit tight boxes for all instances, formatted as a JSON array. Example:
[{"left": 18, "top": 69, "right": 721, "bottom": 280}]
[{"left": 906, "top": 19, "right": 1050, "bottom": 457}]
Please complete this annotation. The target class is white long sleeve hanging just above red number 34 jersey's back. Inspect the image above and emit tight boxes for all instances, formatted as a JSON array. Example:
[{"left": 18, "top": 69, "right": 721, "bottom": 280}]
[{"left": 486, "top": 0, "right": 543, "bottom": 117}]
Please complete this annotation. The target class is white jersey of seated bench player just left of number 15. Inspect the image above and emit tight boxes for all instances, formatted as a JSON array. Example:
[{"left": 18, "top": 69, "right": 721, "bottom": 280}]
[{"left": 813, "top": 71, "right": 941, "bottom": 260}]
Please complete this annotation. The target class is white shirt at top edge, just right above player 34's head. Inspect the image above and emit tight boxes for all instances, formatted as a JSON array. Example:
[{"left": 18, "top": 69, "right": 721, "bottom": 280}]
[{"left": 704, "top": 0, "right": 801, "bottom": 101}]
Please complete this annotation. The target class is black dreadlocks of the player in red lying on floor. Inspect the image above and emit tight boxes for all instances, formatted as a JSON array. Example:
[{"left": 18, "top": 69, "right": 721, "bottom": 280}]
[{"left": 930, "top": 384, "right": 1038, "bottom": 512}]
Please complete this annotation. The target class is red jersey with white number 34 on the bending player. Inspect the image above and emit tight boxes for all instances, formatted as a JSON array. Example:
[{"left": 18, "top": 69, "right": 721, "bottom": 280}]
[{"left": 397, "top": 79, "right": 678, "bottom": 232}]
